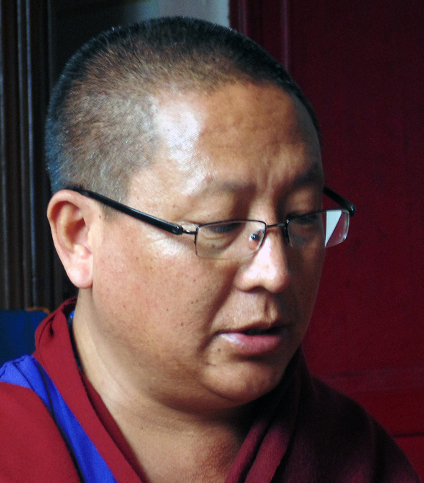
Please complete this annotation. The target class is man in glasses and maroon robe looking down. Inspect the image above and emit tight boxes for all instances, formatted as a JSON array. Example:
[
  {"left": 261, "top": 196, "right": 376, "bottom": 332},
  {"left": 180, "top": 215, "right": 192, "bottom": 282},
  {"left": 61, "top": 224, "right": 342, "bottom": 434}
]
[{"left": 0, "top": 18, "right": 418, "bottom": 483}]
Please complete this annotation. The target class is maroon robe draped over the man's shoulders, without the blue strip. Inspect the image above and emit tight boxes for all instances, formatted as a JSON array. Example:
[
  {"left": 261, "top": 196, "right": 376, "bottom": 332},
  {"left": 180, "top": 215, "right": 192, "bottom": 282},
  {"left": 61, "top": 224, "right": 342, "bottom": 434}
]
[{"left": 0, "top": 302, "right": 419, "bottom": 483}]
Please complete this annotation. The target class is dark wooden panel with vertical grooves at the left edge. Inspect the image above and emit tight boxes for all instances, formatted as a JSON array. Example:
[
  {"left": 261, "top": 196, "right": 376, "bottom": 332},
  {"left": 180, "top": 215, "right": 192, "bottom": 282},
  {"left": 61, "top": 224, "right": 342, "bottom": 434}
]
[{"left": 0, "top": 0, "right": 54, "bottom": 308}]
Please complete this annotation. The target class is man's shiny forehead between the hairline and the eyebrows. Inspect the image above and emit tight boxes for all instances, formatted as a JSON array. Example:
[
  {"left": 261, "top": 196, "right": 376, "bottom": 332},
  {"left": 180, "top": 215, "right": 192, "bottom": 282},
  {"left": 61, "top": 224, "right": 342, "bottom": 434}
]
[{"left": 129, "top": 83, "right": 322, "bottom": 203}]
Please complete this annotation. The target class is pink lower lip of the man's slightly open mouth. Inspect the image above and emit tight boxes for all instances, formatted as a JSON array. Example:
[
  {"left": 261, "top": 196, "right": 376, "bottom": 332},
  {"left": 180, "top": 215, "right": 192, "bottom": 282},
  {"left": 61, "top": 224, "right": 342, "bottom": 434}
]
[{"left": 220, "top": 328, "right": 284, "bottom": 356}]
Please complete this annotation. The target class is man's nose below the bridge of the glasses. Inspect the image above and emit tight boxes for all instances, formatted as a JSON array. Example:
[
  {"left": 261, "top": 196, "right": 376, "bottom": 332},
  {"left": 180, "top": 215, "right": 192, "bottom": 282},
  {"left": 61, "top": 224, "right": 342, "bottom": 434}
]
[{"left": 237, "top": 227, "right": 291, "bottom": 293}]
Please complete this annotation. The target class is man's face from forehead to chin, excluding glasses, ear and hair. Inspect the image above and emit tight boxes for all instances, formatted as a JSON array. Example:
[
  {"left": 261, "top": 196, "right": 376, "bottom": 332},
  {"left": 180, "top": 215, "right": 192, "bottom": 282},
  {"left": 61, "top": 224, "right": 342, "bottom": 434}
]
[{"left": 90, "top": 84, "right": 324, "bottom": 410}]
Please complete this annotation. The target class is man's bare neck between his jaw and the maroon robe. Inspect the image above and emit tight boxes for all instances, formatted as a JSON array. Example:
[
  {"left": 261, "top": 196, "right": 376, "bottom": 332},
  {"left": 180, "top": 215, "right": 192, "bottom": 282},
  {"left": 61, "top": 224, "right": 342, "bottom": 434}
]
[{"left": 73, "top": 294, "right": 252, "bottom": 482}]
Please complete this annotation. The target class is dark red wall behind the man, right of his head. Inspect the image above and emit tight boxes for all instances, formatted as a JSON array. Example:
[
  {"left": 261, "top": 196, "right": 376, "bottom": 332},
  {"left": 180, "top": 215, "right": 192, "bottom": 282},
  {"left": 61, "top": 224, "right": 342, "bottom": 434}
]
[{"left": 232, "top": 0, "right": 424, "bottom": 478}]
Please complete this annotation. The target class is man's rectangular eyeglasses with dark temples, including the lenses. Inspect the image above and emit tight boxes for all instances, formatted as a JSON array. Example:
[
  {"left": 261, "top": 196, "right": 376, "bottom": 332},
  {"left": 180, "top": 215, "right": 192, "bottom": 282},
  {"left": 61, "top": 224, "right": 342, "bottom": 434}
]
[{"left": 67, "top": 187, "right": 356, "bottom": 260}]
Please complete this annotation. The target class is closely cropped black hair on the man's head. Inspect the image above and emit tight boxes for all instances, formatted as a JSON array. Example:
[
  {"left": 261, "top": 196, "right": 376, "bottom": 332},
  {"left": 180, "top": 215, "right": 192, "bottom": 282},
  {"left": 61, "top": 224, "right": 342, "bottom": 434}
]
[{"left": 46, "top": 17, "right": 319, "bottom": 200}]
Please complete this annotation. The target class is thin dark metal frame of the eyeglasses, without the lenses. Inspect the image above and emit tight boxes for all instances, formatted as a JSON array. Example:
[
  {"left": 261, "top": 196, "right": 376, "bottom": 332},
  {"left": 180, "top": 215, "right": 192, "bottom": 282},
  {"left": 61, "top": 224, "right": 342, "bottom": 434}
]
[{"left": 65, "top": 186, "right": 356, "bottom": 253}]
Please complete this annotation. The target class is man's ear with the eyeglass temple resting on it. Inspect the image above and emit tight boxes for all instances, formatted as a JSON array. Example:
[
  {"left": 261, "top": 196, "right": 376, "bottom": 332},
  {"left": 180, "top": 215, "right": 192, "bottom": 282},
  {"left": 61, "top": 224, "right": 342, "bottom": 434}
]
[{"left": 47, "top": 190, "right": 96, "bottom": 289}]
